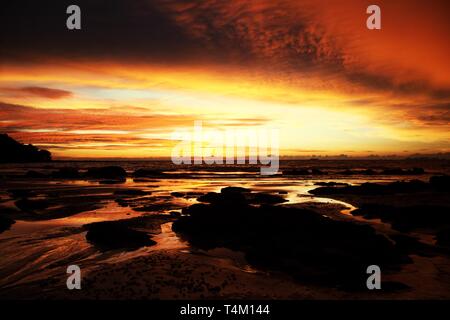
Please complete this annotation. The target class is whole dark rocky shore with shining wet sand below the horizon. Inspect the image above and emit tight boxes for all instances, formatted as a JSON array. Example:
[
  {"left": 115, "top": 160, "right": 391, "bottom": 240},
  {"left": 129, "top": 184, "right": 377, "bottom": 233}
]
[{"left": 0, "top": 160, "right": 450, "bottom": 299}]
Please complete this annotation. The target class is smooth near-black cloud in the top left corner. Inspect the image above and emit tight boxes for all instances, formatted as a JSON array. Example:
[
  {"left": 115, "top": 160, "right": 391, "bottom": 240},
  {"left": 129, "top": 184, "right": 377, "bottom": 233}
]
[{"left": 0, "top": 0, "right": 206, "bottom": 61}]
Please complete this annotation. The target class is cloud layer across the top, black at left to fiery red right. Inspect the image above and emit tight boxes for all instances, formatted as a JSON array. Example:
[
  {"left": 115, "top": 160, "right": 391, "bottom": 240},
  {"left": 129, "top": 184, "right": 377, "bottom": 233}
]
[{"left": 0, "top": 0, "right": 450, "bottom": 98}]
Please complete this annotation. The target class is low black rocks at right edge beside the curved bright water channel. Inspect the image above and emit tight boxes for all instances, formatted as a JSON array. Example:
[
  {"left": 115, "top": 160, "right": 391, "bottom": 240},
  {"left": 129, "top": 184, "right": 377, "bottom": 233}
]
[{"left": 310, "top": 176, "right": 450, "bottom": 234}]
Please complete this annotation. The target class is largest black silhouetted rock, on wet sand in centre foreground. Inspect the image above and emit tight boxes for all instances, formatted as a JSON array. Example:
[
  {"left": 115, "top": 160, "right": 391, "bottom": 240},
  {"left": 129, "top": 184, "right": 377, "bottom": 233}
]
[{"left": 173, "top": 201, "right": 411, "bottom": 289}]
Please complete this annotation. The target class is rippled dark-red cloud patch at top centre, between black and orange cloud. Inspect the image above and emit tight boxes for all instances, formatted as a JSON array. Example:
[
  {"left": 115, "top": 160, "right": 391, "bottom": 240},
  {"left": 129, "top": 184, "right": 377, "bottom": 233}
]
[{"left": 159, "top": 0, "right": 342, "bottom": 69}]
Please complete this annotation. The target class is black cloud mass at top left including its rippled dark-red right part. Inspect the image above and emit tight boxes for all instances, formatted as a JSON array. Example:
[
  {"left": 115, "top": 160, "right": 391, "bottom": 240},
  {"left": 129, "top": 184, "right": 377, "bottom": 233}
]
[{"left": 0, "top": 0, "right": 340, "bottom": 68}]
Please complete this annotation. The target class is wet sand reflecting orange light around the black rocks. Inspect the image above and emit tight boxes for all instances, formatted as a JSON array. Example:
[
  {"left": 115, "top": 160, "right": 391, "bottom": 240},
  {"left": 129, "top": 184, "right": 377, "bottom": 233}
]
[{"left": 0, "top": 161, "right": 450, "bottom": 299}]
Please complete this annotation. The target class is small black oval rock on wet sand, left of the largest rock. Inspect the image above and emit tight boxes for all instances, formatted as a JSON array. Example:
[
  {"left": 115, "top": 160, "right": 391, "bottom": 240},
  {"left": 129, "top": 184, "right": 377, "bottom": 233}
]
[{"left": 85, "top": 221, "right": 156, "bottom": 250}]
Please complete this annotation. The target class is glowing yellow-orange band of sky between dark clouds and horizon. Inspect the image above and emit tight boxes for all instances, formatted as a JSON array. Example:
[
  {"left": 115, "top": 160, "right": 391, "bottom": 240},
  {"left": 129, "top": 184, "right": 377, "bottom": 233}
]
[{"left": 0, "top": 59, "right": 449, "bottom": 158}]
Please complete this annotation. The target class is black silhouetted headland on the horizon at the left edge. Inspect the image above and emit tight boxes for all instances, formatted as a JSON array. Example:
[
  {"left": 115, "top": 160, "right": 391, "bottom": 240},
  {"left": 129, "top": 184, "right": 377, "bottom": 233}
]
[{"left": 0, "top": 134, "right": 52, "bottom": 163}]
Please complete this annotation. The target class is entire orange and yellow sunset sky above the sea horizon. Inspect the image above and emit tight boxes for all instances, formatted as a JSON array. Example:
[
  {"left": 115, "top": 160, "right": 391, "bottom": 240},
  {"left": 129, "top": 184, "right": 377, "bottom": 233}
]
[{"left": 0, "top": 0, "right": 450, "bottom": 158}]
